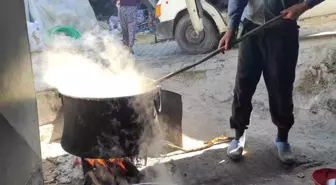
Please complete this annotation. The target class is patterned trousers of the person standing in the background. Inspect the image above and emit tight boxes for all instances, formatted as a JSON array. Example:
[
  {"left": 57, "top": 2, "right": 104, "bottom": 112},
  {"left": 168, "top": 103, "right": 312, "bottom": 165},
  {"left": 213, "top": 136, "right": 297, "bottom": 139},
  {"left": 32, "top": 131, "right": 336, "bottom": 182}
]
[{"left": 119, "top": 6, "right": 137, "bottom": 47}]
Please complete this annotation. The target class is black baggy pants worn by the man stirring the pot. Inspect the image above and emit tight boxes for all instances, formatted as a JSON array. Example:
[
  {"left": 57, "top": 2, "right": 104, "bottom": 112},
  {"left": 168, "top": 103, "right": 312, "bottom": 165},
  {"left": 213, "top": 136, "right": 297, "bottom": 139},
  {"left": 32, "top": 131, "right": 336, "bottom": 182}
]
[{"left": 230, "top": 20, "right": 299, "bottom": 137}]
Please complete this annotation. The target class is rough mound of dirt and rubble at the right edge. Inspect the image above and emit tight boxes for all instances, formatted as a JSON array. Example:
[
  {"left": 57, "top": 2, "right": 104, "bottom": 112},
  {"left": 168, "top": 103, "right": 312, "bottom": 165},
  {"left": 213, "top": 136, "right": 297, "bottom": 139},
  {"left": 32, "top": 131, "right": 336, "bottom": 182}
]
[{"left": 295, "top": 40, "right": 336, "bottom": 114}]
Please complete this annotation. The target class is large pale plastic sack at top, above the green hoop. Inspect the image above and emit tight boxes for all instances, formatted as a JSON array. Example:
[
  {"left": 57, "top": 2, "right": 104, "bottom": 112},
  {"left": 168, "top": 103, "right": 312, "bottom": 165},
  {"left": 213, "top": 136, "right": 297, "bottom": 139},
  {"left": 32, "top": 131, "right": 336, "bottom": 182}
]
[{"left": 28, "top": 0, "right": 97, "bottom": 32}]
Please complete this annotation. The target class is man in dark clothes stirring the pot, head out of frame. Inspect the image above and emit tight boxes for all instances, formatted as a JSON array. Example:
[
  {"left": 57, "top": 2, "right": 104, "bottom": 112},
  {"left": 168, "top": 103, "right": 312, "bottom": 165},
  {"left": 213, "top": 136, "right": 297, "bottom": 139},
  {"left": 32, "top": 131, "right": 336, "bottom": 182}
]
[{"left": 219, "top": 0, "right": 323, "bottom": 163}]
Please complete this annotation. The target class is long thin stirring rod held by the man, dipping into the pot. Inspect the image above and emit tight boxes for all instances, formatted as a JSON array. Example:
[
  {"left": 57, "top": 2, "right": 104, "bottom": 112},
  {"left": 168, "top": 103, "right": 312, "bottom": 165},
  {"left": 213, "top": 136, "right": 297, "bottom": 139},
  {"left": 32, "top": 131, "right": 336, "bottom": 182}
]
[{"left": 153, "top": 15, "right": 283, "bottom": 85}]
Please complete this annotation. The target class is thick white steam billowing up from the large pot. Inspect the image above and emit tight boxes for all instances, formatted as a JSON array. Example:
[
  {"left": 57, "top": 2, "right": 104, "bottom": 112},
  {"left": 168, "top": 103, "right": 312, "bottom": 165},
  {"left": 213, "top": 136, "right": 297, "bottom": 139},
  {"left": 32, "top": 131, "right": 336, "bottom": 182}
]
[{"left": 44, "top": 32, "right": 153, "bottom": 98}]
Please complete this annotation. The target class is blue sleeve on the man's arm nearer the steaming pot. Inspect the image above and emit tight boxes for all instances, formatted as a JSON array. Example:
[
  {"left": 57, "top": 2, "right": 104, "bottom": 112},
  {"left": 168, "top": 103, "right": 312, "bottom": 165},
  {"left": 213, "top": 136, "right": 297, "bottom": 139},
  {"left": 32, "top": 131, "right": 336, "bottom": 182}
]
[{"left": 228, "top": 0, "right": 248, "bottom": 29}]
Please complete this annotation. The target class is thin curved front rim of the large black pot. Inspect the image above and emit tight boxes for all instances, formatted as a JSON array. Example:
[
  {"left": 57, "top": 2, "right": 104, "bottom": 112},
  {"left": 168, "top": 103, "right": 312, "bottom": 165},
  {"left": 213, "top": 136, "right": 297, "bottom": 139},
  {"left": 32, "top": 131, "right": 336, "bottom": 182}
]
[{"left": 57, "top": 77, "right": 161, "bottom": 100}]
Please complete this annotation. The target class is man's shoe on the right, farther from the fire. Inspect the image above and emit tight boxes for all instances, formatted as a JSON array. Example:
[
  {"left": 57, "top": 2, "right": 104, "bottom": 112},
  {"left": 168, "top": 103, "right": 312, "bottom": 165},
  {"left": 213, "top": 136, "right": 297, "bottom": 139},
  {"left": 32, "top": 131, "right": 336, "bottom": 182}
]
[{"left": 274, "top": 140, "right": 294, "bottom": 164}]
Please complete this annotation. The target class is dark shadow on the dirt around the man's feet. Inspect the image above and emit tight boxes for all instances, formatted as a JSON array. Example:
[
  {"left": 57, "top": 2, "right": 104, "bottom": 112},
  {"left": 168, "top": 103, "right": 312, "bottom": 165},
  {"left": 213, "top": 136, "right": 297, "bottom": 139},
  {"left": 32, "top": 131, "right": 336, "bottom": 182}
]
[{"left": 140, "top": 135, "right": 322, "bottom": 185}]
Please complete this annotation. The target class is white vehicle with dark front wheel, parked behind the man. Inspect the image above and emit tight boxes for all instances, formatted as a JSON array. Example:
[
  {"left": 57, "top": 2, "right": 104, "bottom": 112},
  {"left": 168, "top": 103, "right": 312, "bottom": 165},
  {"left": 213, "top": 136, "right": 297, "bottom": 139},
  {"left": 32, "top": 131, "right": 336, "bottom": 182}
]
[{"left": 155, "top": 0, "right": 228, "bottom": 54}]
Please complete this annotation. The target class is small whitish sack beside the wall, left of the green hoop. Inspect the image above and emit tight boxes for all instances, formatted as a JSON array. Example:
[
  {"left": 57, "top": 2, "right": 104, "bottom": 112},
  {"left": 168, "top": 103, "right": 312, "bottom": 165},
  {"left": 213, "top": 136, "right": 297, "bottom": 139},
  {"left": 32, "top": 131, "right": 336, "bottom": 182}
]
[{"left": 27, "top": 21, "right": 46, "bottom": 52}]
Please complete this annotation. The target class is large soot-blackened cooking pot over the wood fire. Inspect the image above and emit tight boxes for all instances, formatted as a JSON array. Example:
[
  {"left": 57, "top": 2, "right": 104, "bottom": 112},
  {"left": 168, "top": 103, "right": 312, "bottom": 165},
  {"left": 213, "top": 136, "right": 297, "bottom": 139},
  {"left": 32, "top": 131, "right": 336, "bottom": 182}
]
[{"left": 59, "top": 79, "right": 160, "bottom": 159}]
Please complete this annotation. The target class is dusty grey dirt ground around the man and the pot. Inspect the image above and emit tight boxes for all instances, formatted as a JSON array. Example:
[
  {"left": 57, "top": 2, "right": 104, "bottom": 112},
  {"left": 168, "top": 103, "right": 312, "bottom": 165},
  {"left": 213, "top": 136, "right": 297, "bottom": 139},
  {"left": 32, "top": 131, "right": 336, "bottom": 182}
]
[{"left": 34, "top": 16, "right": 336, "bottom": 185}]
